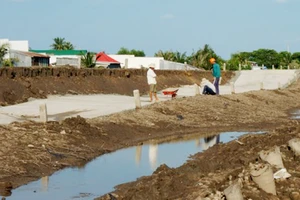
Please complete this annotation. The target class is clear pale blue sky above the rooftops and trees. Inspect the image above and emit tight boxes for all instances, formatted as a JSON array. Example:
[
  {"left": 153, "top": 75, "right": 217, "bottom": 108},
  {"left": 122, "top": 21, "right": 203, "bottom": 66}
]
[{"left": 0, "top": 0, "right": 300, "bottom": 59}]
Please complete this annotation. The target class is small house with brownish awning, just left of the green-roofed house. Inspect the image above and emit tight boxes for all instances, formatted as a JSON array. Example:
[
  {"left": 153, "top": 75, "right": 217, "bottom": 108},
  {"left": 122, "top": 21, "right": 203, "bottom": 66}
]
[{"left": 9, "top": 50, "right": 50, "bottom": 67}]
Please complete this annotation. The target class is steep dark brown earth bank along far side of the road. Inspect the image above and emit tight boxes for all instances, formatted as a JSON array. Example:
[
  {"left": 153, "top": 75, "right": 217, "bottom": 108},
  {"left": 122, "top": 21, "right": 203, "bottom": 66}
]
[{"left": 0, "top": 68, "right": 233, "bottom": 105}]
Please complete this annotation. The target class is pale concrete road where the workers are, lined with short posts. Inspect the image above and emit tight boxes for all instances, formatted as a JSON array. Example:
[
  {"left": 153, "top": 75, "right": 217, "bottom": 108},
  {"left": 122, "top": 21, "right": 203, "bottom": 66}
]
[{"left": 0, "top": 70, "right": 299, "bottom": 124}]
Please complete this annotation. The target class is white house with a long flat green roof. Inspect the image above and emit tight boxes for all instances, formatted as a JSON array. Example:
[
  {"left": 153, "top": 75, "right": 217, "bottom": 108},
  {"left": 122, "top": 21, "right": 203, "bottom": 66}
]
[{"left": 30, "top": 50, "right": 87, "bottom": 68}]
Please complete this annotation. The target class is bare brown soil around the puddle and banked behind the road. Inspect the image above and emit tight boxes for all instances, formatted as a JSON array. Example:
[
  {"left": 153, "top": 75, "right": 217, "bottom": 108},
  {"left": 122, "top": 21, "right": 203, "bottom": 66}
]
[{"left": 0, "top": 69, "right": 300, "bottom": 199}]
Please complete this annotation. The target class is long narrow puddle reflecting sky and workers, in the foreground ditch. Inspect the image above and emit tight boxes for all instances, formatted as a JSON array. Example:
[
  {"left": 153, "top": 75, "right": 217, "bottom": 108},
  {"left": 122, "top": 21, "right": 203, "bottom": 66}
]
[{"left": 5, "top": 132, "right": 262, "bottom": 200}]
